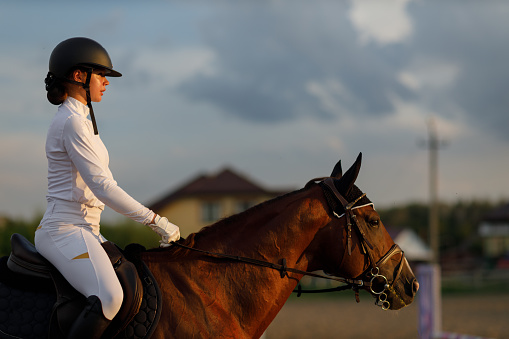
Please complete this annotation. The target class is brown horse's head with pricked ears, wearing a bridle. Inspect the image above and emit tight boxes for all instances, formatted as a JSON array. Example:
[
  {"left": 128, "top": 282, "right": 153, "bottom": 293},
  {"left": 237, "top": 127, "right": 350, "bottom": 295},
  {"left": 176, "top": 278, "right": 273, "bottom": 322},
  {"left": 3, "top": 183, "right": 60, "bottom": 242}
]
[{"left": 314, "top": 154, "right": 419, "bottom": 310}]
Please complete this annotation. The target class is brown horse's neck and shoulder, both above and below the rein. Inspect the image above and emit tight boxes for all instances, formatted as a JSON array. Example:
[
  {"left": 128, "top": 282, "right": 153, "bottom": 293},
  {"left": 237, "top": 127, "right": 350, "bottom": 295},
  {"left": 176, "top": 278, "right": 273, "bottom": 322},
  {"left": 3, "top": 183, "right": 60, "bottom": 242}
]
[{"left": 146, "top": 189, "right": 327, "bottom": 338}]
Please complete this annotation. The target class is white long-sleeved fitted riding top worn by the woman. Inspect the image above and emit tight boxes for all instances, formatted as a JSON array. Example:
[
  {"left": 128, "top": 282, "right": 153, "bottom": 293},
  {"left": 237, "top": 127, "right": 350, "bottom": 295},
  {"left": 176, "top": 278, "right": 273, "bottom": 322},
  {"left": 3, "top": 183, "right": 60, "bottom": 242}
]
[{"left": 46, "top": 97, "right": 154, "bottom": 225}]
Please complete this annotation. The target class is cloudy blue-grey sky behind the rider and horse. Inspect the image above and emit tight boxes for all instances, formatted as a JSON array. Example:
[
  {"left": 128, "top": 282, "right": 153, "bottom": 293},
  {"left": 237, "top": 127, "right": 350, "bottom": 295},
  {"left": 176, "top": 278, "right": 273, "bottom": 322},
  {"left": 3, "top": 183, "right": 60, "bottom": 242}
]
[{"left": 0, "top": 0, "right": 509, "bottom": 223}]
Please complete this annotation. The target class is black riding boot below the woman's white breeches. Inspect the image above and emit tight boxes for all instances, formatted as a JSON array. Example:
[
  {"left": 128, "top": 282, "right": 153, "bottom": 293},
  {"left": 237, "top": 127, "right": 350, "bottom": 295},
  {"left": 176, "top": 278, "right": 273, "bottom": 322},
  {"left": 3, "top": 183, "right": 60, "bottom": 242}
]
[{"left": 67, "top": 295, "right": 111, "bottom": 339}]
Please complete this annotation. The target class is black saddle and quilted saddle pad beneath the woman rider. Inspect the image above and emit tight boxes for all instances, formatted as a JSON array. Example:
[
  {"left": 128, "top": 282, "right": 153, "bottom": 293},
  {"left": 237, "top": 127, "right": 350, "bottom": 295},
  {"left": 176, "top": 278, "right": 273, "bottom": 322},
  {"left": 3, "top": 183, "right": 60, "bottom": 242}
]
[{"left": 0, "top": 233, "right": 161, "bottom": 339}]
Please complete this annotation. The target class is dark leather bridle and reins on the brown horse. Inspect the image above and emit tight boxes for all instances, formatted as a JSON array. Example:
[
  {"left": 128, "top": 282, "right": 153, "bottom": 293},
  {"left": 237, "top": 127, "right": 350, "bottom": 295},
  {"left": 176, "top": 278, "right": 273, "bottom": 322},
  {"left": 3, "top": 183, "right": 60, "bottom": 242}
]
[{"left": 171, "top": 178, "right": 405, "bottom": 310}]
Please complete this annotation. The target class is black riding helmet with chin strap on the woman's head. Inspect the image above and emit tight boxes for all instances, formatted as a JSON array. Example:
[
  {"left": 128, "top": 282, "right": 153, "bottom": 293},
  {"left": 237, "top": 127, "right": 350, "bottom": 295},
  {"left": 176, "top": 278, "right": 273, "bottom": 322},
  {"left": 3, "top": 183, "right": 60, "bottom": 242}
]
[{"left": 45, "top": 37, "right": 122, "bottom": 134}]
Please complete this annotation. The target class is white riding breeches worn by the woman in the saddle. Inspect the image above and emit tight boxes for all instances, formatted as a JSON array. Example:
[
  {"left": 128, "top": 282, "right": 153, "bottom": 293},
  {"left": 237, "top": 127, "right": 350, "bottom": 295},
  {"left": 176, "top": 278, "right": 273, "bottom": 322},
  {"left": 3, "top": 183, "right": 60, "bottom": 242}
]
[{"left": 35, "top": 199, "right": 124, "bottom": 320}]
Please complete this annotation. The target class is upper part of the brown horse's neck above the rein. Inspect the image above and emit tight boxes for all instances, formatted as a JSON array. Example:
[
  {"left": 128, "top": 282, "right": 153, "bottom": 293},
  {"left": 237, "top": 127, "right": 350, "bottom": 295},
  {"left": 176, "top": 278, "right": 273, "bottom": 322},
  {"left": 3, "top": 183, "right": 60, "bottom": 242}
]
[{"left": 192, "top": 188, "right": 327, "bottom": 263}]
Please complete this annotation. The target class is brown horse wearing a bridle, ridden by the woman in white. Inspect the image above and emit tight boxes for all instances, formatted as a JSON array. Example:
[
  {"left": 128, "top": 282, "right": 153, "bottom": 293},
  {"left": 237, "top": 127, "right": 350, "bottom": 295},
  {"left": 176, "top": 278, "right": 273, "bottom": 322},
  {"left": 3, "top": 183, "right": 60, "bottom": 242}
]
[{"left": 142, "top": 155, "right": 418, "bottom": 338}]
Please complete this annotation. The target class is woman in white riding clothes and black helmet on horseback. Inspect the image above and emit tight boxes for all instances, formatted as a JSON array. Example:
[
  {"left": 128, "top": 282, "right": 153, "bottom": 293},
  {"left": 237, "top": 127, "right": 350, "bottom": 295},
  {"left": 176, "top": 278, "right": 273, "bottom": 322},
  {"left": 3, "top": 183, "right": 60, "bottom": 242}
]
[{"left": 35, "top": 38, "right": 180, "bottom": 339}]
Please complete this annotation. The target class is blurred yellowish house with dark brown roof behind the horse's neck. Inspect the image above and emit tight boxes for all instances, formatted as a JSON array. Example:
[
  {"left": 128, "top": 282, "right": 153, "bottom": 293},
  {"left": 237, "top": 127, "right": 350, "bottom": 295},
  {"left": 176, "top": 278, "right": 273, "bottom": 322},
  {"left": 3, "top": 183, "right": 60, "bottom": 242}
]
[{"left": 149, "top": 168, "right": 291, "bottom": 237}]
